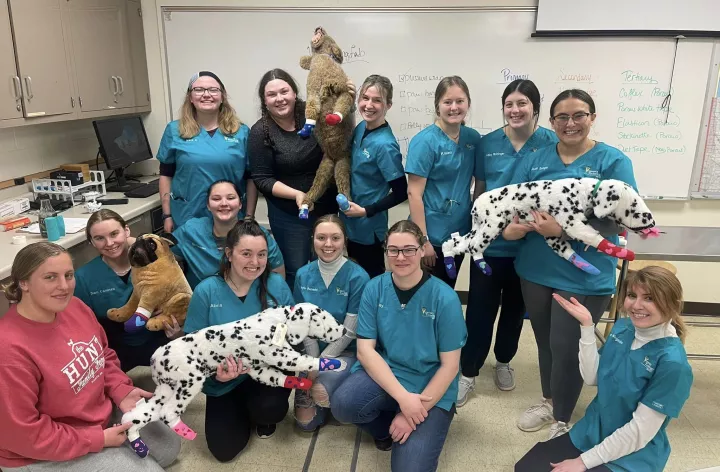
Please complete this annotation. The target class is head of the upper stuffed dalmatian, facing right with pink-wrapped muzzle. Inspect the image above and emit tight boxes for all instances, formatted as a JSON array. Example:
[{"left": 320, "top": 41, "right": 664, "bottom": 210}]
[{"left": 593, "top": 180, "right": 655, "bottom": 236}]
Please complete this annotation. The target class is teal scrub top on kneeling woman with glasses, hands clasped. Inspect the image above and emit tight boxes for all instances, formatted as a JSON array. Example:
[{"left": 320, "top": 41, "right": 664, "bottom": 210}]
[{"left": 352, "top": 272, "right": 467, "bottom": 411}]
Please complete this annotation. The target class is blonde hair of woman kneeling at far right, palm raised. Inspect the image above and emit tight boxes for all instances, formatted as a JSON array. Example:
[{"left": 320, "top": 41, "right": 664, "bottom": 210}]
[{"left": 620, "top": 266, "right": 687, "bottom": 343}]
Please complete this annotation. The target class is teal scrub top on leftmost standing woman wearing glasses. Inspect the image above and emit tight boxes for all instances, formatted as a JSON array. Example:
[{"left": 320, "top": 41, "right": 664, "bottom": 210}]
[{"left": 157, "top": 120, "right": 250, "bottom": 228}]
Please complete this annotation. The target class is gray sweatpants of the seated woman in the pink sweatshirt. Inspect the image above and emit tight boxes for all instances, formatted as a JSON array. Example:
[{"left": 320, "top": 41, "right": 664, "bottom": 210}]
[{"left": 2, "top": 408, "right": 180, "bottom": 472}]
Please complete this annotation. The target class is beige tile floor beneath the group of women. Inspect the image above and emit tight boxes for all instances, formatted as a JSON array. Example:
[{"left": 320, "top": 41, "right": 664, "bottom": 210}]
[{"left": 132, "top": 321, "right": 720, "bottom": 472}]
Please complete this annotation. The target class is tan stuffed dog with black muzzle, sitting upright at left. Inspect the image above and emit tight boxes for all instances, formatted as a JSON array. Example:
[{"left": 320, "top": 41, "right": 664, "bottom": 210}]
[{"left": 107, "top": 234, "right": 192, "bottom": 333}]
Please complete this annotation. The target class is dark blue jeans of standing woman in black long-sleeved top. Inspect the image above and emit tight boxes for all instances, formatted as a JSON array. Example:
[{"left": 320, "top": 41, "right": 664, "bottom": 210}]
[{"left": 266, "top": 200, "right": 317, "bottom": 290}]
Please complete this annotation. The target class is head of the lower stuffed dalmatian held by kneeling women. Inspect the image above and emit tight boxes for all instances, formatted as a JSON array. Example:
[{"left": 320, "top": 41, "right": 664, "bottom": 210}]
[{"left": 285, "top": 303, "right": 345, "bottom": 345}]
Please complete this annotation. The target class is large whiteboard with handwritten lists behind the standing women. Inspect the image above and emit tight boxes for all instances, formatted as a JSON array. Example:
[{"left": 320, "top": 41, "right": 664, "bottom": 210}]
[{"left": 163, "top": 7, "right": 713, "bottom": 198}]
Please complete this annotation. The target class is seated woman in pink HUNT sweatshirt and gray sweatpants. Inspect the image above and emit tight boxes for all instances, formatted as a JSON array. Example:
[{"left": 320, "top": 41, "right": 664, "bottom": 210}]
[{"left": 0, "top": 242, "right": 180, "bottom": 472}]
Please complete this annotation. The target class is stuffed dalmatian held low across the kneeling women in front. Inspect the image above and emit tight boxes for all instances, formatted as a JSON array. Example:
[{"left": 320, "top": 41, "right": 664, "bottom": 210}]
[{"left": 122, "top": 303, "right": 346, "bottom": 457}]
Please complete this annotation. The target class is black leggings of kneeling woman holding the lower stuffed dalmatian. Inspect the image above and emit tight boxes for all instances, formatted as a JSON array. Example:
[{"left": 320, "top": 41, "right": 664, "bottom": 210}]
[{"left": 205, "top": 378, "right": 291, "bottom": 462}]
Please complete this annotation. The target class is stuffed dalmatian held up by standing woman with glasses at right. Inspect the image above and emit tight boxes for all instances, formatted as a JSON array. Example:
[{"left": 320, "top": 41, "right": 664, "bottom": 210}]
[{"left": 442, "top": 178, "right": 659, "bottom": 278}]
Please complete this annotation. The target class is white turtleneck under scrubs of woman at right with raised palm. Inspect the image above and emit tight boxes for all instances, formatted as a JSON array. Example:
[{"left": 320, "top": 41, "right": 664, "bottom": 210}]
[{"left": 578, "top": 323, "right": 677, "bottom": 469}]
